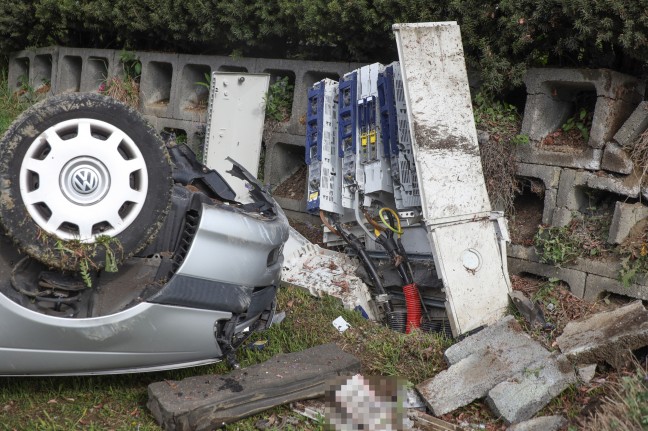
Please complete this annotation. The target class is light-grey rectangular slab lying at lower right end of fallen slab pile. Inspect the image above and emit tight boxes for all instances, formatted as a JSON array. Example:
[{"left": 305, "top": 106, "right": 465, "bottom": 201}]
[{"left": 486, "top": 355, "right": 577, "bottom": 425}]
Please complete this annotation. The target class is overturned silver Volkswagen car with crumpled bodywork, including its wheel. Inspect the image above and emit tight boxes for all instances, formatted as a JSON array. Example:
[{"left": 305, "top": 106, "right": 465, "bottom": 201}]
[{"left": 0, "top": 93, "right": 289, "bottom": 375}]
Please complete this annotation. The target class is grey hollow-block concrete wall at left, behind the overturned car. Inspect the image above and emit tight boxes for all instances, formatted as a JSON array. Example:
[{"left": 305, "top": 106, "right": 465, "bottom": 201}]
[{"left": 9, "top": 47, "right": 361, "bottom": 203}]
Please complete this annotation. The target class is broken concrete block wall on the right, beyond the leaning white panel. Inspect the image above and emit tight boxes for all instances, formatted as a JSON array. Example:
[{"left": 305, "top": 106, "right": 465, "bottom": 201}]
[{"left": 508, "top": 69, "right": 648, "bottom": 300}]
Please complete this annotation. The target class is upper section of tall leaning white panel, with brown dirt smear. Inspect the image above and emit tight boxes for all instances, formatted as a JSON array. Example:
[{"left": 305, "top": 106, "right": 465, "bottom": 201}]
[{"left": 394, "top": 22, "right": 491, "bottom": 220}]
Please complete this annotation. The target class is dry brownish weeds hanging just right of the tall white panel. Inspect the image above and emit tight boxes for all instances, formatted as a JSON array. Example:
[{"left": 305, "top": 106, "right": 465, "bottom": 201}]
[{"left": 473, "top": 93, "right": 529, "bottom": 214}]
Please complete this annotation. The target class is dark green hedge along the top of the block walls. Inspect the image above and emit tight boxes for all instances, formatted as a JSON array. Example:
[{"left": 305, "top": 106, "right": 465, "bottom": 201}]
[{"left": 0, "top": 0, "right": 648, "bottom": 92}]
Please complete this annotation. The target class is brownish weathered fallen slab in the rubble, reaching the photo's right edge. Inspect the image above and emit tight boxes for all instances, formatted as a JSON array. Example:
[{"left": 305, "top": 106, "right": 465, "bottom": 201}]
[{"left": 556, "top": 301, "right": 648, "bottom": 368}]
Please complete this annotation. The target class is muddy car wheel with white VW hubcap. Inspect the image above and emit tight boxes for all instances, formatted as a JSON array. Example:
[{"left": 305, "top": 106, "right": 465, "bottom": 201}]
[{"left": 0, "top": 93, "right": 172, "bottom": 270}]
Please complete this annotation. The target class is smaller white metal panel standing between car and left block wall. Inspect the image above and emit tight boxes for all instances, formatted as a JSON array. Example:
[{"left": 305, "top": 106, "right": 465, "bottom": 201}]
[{"left": 203, "top": 72, "right": 270, "bottom": 200}]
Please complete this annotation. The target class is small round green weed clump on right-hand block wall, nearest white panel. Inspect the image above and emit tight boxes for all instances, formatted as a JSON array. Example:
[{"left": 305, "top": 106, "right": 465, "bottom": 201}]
[{"left": 533, "top": 226, "right": 580, "bottom": 266}]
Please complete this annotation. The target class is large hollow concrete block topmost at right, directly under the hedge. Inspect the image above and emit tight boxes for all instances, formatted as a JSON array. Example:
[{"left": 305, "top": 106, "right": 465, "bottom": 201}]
[{"left": 522, "top": 68, "right": 645, "bottom": 148}]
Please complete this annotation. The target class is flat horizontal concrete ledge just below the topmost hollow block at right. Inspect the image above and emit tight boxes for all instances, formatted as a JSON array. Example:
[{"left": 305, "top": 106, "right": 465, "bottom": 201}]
[{"left": 515, "top": 145, "right": 603, "bottom": 171}]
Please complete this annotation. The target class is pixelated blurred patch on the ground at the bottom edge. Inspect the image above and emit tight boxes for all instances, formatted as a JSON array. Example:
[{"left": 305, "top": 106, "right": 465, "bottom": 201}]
[{"left": 324, "top": 374, "right": 407, "bottom": 431}]
